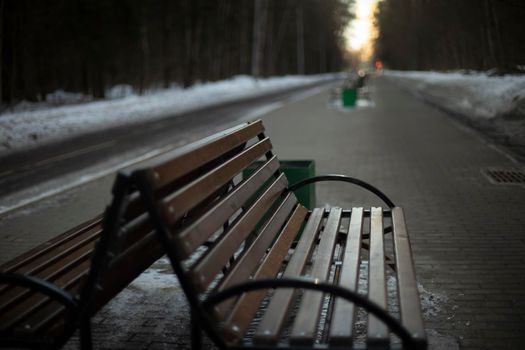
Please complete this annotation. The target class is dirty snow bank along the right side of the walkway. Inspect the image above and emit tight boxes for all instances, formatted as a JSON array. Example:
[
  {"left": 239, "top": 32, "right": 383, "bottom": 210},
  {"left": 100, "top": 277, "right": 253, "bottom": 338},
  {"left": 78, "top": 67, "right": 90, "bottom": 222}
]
[{"left": 384, "top": 71, "right": 525, "bottom": 146}]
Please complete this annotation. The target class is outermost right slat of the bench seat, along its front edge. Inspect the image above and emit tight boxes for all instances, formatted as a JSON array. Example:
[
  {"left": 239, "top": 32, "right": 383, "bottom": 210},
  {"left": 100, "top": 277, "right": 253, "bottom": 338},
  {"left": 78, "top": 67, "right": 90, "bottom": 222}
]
[{"left": 392, "top": 207, "right": 426, "bottom": 348}]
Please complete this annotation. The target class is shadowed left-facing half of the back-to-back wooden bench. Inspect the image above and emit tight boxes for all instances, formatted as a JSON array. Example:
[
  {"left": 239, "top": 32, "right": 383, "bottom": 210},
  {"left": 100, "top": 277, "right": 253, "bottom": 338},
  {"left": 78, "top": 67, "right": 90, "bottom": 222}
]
[{"left": 0, "top": 175, "right": 181, "bottom": 349}]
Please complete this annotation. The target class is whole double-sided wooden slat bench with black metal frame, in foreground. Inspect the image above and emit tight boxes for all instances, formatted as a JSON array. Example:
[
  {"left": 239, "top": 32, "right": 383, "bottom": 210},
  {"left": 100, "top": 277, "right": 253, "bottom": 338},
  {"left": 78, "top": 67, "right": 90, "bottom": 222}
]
[{"left": 0, "top": 121, "right": 426, "bottom": 349}]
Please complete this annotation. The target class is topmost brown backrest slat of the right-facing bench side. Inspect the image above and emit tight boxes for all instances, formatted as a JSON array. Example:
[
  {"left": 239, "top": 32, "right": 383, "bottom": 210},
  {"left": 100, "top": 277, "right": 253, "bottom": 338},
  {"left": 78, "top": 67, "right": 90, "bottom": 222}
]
[{"left": 152, "top": 120, "right": 264, "bottom": 188}]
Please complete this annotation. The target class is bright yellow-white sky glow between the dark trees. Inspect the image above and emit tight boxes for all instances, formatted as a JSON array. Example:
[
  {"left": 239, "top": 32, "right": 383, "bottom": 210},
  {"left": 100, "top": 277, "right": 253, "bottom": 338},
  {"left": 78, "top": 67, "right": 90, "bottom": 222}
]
[{"left": 346, "top": 0, "right": 377, "bottom": 61}]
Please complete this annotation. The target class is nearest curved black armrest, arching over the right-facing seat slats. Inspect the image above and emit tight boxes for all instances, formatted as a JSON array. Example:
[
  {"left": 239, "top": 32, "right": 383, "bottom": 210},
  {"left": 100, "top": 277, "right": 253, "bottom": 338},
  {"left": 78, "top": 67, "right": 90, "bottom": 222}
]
[{"left": 202, "top": 278, "right": 421, "bottom": 350}]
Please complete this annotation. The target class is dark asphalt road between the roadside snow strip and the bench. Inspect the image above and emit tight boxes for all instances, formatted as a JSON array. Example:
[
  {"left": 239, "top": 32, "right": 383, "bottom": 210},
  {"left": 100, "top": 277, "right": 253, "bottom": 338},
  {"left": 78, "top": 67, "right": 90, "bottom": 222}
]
[{"left": 0, "top": 81, "right": 334, "bottom": 216}]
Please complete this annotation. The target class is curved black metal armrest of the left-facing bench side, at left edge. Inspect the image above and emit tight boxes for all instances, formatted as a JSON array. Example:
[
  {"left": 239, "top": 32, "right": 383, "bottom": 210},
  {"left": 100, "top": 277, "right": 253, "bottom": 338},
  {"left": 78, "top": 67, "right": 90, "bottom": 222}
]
[{"left": 0, "top": 272, "right": 78, "bottom": 308}]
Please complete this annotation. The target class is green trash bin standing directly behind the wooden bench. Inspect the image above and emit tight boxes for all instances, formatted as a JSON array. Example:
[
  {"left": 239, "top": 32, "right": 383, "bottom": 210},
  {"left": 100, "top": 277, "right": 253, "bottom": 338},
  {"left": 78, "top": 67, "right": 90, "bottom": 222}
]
[{"left": 242, "top": 160, "right": 315, "bottom": 209}]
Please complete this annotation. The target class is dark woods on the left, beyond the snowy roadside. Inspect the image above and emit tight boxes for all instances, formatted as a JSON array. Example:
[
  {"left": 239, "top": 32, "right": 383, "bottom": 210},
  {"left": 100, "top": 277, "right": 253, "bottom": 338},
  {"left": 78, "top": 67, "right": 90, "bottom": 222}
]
[{"left": 0, "top": 0, "right": 353, "bottom": 104}]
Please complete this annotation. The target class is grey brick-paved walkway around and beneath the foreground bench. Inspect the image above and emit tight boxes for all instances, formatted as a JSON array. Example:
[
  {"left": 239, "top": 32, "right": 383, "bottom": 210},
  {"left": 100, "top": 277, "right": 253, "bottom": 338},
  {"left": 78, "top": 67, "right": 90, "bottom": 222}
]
[{"left": 60, "top": 79, "right": 525, "bottom": 349}]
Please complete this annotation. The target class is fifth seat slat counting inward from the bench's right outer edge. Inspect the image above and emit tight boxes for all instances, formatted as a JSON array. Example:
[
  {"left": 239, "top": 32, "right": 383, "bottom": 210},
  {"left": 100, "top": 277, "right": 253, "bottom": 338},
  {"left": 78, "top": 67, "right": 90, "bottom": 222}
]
[{"left": 254, "top": 208, "right": 324, "bottom": 344}]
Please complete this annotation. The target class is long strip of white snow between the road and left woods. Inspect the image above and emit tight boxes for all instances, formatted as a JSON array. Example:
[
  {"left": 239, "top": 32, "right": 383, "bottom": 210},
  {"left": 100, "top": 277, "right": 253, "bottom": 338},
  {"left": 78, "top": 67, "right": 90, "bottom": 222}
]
[{"left": 0, "top": 74, "right": 334, "bottom": 156}]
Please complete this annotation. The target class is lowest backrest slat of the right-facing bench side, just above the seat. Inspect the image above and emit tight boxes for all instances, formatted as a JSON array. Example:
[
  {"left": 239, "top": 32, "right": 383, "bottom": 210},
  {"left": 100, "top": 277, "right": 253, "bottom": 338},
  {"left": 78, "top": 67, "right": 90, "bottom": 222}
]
[{"left": 217, "top": 193, "right": 297, "bottom": 319}]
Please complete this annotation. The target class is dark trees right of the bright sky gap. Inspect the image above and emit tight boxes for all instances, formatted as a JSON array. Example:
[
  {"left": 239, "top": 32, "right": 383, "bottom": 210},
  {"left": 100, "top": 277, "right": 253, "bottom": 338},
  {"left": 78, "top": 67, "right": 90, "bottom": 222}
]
[{"left": 376, "top": 0, "right": 525, "bottom": 73}]
